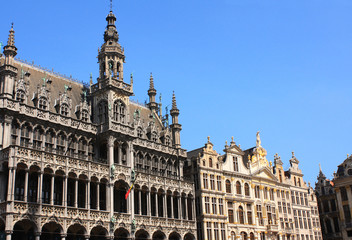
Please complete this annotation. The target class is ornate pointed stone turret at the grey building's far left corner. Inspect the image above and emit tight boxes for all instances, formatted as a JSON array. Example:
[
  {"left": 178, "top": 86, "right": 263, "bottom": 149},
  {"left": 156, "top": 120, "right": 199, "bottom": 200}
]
[{"left": 0, "top": 24, "right": 18, "bottom": 97}]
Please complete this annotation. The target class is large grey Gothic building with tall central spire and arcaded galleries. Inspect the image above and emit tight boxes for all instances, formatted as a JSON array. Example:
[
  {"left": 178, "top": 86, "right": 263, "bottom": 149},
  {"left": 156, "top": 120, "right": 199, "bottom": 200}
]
[{"left": 0, "top": 11, "right": 196, "bottom": 240}]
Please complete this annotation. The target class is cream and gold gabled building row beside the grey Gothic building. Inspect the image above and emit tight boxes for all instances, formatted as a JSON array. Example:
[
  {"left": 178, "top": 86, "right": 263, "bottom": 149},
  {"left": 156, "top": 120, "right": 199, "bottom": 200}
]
[{"left": 185, "top": 132, "right": 321, "bottom": 240}]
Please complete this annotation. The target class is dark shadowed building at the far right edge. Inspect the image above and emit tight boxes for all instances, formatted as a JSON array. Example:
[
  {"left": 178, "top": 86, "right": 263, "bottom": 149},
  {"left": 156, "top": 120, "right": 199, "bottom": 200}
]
[{"left": 315, "top": 156, "right": 352, "bottom": 240}]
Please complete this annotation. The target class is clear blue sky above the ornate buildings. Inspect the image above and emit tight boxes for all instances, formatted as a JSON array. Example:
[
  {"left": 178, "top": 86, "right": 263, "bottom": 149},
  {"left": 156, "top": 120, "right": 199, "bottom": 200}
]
[{"left": 0, "top": 0, "right": 352, "bottom": 184}]
